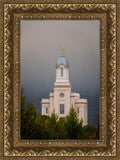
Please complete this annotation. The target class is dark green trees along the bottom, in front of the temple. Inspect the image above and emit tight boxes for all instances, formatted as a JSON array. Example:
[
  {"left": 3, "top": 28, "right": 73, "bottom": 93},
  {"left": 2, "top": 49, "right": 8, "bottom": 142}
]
[{"left": 21, "top": 89, "right": 99, "bottom": 139}]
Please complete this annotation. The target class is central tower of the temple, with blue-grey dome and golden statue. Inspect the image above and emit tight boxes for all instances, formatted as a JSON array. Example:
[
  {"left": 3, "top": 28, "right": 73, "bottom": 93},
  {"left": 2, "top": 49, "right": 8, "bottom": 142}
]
[{"left": 54, "top": 47, "right": 71, "bottom": 117}]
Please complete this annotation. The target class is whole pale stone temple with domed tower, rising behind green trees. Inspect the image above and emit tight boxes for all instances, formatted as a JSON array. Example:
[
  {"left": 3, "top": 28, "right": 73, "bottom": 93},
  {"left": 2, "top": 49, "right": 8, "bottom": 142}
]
[{"left": 41, "top": 47, "right": 88, "bottom": 125}]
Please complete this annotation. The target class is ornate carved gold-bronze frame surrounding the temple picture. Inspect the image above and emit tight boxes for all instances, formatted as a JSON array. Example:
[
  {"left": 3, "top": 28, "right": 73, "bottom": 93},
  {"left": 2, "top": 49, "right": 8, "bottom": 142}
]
[{"left": 0, "top": 0, "right": 120, "bottom": 160}]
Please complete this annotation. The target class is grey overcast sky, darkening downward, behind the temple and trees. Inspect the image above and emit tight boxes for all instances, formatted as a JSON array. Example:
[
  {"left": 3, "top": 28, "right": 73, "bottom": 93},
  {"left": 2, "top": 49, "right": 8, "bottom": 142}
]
[{"left": 21, "top": 20, "right": 99, "bottom": 125}]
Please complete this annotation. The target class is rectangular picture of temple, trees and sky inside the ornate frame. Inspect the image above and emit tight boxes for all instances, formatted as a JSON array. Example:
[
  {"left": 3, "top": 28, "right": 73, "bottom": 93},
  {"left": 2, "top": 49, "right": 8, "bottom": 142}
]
[{"left": 20, "top": 20, "right": 100, "bottom": 139}]
